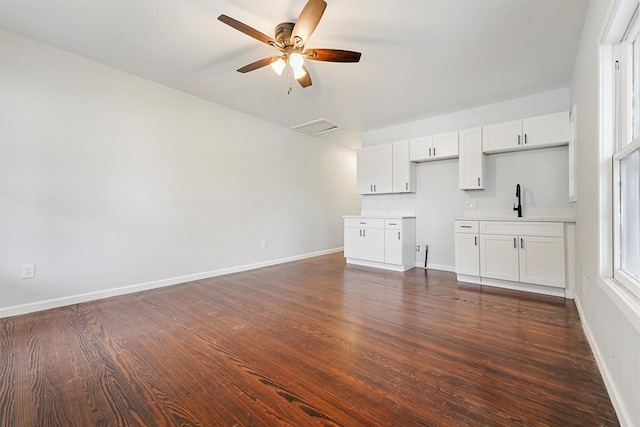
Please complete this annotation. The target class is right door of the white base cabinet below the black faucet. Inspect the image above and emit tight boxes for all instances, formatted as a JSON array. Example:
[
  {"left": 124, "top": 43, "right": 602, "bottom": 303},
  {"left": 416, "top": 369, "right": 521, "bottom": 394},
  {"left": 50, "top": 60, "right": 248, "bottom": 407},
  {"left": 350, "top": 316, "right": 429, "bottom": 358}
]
[{"left": 519, "top": 236, "right": 565, "bottom": 288}]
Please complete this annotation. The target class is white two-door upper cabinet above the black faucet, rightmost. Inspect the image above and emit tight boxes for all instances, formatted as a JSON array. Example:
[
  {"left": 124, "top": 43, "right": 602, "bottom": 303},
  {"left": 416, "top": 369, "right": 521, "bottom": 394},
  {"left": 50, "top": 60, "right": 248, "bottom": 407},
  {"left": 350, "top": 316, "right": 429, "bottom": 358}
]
[{"left": 482, "top": 111, "right": 569, "bottom": 153}]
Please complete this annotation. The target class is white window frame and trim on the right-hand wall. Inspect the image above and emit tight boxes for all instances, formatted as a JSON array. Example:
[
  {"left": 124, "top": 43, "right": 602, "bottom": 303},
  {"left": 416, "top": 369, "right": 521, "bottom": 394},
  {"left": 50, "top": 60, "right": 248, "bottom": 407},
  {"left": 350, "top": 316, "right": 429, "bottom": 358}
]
[{"left": 598, "top": 0, "right": 640, "bottom": 332}]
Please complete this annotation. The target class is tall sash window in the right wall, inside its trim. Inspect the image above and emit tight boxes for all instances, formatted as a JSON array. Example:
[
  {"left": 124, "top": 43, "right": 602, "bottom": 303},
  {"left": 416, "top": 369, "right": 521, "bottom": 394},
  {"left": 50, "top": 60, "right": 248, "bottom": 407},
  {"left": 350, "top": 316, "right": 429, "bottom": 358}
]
[{"left": 603, "top": 2, "right": 640, "bottom": 304}]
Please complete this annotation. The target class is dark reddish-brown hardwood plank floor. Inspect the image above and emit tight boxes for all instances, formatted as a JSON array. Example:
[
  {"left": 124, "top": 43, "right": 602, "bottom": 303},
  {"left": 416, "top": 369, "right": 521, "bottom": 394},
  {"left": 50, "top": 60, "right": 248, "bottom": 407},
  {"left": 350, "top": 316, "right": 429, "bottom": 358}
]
[{"left": 0, "top": 254, "right": 618, "bottom": 427}]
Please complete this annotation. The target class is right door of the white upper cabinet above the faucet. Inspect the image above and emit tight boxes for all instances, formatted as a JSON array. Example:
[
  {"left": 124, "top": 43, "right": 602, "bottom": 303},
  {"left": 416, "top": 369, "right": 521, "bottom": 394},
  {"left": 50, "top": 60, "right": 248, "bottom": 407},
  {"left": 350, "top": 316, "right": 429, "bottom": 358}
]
[{"left": 522, "top": 111, "right": 569, "bottom": 148}]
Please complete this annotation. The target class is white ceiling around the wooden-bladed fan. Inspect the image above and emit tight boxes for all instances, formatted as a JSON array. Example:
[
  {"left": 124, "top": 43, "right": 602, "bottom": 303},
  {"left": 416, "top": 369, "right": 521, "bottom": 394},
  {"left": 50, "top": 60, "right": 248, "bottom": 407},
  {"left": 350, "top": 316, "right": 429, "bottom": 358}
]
[{"left": 0, "top": 0, "right": 588, "bottom": 148}]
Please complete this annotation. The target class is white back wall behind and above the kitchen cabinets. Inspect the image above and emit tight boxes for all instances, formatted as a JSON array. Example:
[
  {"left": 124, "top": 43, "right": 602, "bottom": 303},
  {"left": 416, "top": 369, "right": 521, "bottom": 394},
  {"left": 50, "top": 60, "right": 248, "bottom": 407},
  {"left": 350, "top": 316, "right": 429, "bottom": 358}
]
[{"left": 361, "top": 88, "right": 573, "bottom": 271}]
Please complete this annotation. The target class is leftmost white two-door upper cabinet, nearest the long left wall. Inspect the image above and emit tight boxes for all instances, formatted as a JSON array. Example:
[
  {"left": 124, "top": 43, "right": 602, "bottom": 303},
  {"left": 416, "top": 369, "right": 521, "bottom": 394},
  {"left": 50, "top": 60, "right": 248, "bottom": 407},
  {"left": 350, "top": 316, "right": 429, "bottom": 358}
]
[{"left": 357, "top": 144, "right": 393, "bottom": 194}]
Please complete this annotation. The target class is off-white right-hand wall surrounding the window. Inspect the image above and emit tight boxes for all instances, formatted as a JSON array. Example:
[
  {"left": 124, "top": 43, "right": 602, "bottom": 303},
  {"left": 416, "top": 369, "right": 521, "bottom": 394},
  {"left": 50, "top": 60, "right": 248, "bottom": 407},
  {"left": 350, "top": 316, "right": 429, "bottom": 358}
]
[{"left": 571, "top": 0, "right": 640, "bottom": 426}]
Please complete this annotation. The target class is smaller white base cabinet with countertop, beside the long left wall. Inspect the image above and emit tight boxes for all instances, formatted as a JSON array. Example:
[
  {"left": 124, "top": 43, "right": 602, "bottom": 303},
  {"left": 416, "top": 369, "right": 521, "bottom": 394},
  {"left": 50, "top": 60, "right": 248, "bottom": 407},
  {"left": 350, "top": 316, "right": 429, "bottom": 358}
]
[{"left": 344, "top": 216, "right": 416, "bottom": 271}]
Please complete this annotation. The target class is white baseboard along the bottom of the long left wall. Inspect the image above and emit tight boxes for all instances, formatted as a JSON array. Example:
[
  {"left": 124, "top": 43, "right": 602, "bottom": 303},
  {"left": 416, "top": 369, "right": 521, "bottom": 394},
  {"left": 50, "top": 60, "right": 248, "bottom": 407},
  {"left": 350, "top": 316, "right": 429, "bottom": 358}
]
[{"left": 0, "top": 248, "right": 343, "bottom": 319}]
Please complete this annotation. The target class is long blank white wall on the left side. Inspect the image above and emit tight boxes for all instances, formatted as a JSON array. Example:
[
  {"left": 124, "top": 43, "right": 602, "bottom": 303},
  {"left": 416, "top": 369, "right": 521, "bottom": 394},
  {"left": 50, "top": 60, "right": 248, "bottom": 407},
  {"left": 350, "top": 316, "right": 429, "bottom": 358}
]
[{"left": 0, "top": 32, "right": 360, "bottom": 316}]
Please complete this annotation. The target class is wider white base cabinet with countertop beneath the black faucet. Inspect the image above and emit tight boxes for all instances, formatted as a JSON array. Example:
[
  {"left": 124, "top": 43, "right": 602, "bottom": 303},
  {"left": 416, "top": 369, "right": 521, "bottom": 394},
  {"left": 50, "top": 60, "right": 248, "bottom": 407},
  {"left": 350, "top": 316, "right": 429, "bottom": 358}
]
[{"left": 456, "top": 221, "right": 567, "bottom": 296}]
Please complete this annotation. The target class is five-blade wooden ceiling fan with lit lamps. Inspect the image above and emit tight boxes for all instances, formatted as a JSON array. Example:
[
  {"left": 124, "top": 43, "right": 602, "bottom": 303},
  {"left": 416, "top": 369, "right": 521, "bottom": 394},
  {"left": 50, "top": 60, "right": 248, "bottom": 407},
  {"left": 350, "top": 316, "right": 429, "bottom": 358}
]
[{"left": 218, "top": 0, "right": 361, "bottom": 88}]
